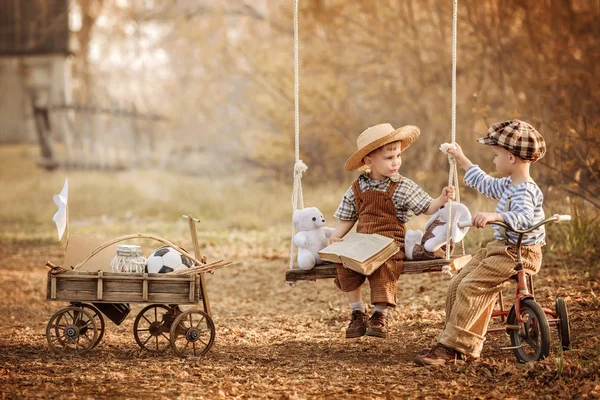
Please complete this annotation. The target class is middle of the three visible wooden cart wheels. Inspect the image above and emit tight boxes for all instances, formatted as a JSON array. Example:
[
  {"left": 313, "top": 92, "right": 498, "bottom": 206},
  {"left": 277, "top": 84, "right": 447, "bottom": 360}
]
[{"left": 133, "top": 304, "right": 174, "bottom": 352}]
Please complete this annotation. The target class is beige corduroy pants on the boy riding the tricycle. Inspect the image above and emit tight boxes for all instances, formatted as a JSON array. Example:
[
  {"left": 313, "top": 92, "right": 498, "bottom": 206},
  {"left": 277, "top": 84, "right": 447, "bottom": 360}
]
[{"left": 438, "top": 240, "right": 542, "bottom": 357}]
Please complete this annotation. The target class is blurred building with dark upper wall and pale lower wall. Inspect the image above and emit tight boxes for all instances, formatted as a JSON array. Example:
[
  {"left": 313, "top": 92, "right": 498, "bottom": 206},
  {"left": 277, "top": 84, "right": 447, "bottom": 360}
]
[{"left": 0, "top": 0, "right": 71, "bottom": 143}]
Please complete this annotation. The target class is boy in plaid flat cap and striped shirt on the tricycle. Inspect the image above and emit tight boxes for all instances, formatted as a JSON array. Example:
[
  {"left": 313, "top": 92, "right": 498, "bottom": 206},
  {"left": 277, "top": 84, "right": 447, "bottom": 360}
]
[{"left": 414, "top": 119, "right": 546, "bottom": 365}]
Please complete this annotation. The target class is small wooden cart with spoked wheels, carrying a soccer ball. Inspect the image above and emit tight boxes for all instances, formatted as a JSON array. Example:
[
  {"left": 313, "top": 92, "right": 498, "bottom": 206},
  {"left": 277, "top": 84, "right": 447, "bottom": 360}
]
[{"left": 46, "top": 216, "right": 221, "bottom": 357}]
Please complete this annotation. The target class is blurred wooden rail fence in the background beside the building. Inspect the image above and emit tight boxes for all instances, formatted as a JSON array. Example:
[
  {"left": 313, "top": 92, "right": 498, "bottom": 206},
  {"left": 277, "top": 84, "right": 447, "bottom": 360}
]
[{"left": 33, "top": 104, "right": 167, "bottom": 170}]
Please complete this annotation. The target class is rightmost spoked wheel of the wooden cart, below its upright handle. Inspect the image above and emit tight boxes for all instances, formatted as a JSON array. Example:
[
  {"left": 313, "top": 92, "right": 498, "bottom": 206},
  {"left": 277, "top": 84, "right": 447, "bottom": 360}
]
[{"left": 171, "top": 310, "right": 215, "bottom": 357}]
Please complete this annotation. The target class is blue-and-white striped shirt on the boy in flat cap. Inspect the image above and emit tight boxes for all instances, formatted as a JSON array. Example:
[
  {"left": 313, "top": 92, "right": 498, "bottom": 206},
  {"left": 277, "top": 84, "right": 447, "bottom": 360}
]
[{"left": 464, "top": 165, "right": 546, "bottom": 245}]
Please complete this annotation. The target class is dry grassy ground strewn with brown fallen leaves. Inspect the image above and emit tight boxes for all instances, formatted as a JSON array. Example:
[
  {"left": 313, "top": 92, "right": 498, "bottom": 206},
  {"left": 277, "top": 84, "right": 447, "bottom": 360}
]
[{"left": 0, "top": 147, "right": 600, "bottom": 399}]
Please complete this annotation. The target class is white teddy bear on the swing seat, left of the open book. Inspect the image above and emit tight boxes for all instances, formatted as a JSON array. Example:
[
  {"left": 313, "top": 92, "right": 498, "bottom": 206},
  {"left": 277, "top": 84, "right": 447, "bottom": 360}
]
[{"left": 293, "top": 207, "right": 334, "bottom": 270}]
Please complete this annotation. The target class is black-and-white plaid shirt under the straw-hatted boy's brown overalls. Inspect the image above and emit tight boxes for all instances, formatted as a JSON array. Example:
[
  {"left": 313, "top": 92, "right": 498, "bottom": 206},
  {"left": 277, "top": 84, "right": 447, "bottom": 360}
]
[{"left": 333, "top": 174, "right": 433, "bottom": 222}]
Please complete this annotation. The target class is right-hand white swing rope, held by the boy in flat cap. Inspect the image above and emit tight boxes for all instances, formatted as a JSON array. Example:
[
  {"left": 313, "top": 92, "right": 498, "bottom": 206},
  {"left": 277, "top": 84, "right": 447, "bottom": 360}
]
[{"left": 446, "top": 0, "right": 465, "bottom": 260}]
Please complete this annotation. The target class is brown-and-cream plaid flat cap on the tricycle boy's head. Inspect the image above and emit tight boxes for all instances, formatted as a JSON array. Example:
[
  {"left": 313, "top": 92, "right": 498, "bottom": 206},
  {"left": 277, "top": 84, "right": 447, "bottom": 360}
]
[{"left": 477, "top": 119, "right": 546, "bottom": 162}]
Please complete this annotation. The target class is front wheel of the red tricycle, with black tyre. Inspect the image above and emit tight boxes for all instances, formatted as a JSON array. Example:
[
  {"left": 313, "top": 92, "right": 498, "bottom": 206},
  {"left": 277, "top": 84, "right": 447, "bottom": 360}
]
[{"left": 507, "top": 299, "right": 550, "bottom": 363}]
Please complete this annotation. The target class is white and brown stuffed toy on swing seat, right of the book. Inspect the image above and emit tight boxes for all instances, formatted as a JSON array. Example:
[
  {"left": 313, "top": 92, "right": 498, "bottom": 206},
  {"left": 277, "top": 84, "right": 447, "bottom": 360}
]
[{"left": 404, "top": 202, "right": 471, "bottom": 260}]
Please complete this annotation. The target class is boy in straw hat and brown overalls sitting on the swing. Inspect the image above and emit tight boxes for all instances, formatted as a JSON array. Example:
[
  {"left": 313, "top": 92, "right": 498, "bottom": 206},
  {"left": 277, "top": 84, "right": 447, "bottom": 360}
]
[{"left": 331, "top": 124, "right": 454, "bottom": 338}]
